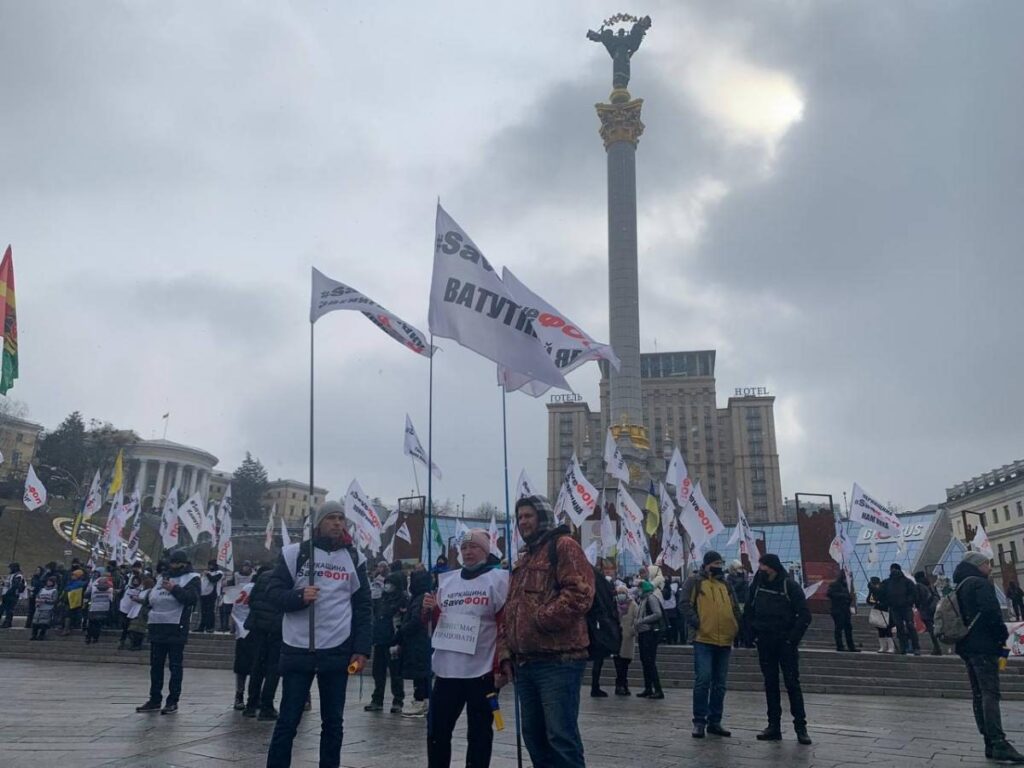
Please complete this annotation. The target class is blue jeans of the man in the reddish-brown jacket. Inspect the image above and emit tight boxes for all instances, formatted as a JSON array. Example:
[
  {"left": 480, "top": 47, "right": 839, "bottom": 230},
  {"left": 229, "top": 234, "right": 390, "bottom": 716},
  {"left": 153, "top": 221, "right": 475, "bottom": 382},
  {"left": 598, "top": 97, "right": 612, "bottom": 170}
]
[{"left": 515, "top": 662, "right": 587, "bottom": 768}]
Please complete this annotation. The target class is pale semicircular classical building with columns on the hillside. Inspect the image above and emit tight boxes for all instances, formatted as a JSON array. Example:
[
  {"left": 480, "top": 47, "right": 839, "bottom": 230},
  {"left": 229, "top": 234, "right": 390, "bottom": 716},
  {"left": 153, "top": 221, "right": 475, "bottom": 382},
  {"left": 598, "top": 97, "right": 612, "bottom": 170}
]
[{"left": 125, "top": 439, "right": 218, "bottom": 508}]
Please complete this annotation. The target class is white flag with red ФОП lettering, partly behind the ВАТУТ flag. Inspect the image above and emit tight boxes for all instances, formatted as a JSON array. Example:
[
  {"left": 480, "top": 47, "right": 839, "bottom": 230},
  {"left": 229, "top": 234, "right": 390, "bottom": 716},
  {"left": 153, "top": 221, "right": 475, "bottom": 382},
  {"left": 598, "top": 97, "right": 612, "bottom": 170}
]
[{"left": 498, "top": 267, "right": 620, "bottom": 397}]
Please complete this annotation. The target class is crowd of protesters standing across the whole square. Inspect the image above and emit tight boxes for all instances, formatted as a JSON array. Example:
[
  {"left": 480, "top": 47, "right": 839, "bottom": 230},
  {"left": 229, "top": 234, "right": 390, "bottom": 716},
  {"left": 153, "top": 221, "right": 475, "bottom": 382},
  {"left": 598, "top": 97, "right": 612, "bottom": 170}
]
[{"left": 6, "top": 496, "right": 1024, "bottom": 768}]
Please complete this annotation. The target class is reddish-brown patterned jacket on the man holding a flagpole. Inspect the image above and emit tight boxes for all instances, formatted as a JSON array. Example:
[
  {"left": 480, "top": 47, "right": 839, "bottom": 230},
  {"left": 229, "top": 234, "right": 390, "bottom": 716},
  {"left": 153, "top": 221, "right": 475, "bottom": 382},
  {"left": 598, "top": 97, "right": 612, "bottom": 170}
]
[{"left": 504, "top": 526, "right": 594, "bottom": 662}]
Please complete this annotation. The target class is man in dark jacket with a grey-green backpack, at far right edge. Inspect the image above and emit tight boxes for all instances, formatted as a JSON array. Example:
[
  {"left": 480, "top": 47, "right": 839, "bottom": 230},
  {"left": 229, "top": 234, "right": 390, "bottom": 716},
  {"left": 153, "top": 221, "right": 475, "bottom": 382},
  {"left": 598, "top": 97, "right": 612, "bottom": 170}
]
[{"left": 953, "top": 552, "right": 1024, "bottom": 764}]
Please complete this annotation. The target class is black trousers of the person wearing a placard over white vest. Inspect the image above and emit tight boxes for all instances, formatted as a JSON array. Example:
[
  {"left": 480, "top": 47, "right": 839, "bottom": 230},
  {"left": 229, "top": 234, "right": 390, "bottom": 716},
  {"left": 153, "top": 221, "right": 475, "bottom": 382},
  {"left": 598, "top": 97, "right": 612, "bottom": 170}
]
[{"left": 427, "top": 675, "right": 495, "bottom": 768}]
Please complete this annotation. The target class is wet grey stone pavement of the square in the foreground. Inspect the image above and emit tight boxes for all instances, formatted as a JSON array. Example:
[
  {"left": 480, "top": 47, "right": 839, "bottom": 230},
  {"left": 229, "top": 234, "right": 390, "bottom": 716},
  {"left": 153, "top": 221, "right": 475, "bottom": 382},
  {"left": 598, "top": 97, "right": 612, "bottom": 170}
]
[{"left": 0, "top": 659, "right": 1024, "bottom": 768}]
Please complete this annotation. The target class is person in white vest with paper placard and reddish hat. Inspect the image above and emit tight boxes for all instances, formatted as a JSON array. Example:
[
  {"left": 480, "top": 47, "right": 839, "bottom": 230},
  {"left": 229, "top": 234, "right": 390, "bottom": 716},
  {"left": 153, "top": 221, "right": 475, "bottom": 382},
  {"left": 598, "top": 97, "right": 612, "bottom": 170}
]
[{"left": 423, "top": 528, "right": 509, "bottom": 768}]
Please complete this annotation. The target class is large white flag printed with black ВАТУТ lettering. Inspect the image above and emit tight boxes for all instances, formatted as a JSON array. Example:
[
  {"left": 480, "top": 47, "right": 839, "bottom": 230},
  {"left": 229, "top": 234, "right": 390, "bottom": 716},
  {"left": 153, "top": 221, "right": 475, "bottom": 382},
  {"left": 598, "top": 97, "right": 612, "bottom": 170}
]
[{"left": 428, "top": 205, "right": 569, "bottom": 389}]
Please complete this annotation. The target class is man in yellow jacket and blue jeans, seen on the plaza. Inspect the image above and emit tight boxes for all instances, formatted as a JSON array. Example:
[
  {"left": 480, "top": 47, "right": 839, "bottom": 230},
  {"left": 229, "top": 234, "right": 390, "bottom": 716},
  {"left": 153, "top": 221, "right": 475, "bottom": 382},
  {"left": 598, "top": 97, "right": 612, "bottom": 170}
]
[{"left": 680, "top": 551, "right": 739, "bottom": 738}]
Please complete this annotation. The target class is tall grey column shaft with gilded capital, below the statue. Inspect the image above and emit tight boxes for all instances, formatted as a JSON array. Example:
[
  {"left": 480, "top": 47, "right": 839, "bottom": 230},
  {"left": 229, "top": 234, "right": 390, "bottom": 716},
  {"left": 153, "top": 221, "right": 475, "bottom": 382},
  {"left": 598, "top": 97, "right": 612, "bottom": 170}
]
[{"left": 595, "top": 93, "right": 650, "bottom": 473}]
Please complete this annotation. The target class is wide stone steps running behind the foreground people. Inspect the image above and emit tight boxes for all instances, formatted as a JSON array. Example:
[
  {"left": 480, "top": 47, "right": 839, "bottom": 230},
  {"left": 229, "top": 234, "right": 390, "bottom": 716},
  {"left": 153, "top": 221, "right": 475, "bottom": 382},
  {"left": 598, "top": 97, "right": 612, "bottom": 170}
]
[{"left": 0, "top": 615, "right": 1024, "bottom": 700}]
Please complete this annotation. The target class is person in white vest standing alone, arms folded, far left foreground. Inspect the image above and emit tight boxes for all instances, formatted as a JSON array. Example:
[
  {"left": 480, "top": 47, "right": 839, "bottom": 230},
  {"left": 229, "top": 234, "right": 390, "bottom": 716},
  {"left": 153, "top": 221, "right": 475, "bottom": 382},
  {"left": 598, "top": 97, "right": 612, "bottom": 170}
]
[{"left": 135, "top": 551, "right": 199, "bottom": 715}]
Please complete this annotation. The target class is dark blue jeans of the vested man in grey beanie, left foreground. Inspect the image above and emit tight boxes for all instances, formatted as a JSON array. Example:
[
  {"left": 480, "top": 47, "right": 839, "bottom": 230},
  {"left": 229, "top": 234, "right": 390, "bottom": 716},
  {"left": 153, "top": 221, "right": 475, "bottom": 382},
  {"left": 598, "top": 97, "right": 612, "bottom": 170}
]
[{"left": 266, "top": 669, "right": 348, "bottom": 768}]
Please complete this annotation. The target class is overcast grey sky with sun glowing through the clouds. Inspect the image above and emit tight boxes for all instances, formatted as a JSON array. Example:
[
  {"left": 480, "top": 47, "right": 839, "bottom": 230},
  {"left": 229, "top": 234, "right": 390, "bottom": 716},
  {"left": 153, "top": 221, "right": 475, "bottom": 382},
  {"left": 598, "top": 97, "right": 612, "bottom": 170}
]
[{"left": 0, "top": 0, "right": 1024, "bottom": 509}]
